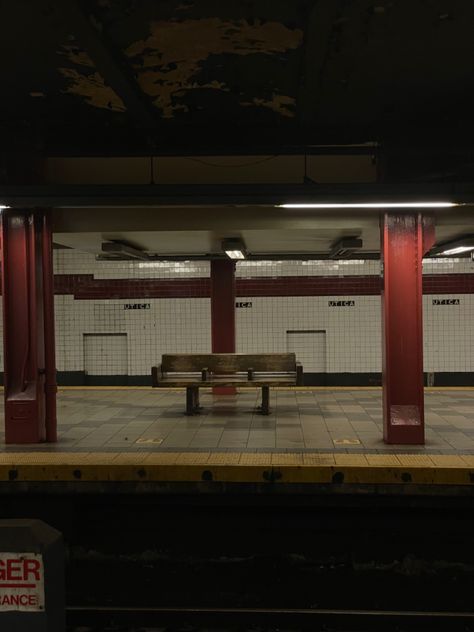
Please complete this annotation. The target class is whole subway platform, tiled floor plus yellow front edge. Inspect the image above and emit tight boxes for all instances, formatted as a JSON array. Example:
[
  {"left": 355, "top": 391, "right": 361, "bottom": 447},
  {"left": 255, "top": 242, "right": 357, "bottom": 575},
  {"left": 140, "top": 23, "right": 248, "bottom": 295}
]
[{"left": 0, "top": 387, "right": 474, "bottom": 494}]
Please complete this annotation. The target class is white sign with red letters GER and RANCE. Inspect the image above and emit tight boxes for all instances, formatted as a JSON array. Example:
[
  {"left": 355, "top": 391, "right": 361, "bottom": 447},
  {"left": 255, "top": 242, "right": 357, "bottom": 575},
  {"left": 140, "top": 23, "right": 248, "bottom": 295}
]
[{"left": 0, "top": 553, "right": 44, "bottom": 612}]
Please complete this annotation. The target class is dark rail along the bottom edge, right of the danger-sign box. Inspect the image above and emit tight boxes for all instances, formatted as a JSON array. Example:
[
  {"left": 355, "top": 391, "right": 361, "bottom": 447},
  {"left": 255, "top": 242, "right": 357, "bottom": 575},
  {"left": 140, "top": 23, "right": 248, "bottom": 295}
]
[{"left": 67, "top": 606, "right": 474, "bottom": 632}]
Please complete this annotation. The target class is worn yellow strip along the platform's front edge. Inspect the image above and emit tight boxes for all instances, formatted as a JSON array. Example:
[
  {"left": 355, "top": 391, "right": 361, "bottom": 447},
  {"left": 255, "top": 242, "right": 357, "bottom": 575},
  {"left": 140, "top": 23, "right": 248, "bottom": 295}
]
[{"left": 0, "top": 452, "right": 474, "bottom": 486}]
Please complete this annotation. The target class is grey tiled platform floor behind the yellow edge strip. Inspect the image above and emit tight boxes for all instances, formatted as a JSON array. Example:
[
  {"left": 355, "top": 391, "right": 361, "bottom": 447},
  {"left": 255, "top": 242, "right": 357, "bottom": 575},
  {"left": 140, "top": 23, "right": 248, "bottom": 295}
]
[{"left": 0, "top": 388, "right": 474, "bottom": 454}]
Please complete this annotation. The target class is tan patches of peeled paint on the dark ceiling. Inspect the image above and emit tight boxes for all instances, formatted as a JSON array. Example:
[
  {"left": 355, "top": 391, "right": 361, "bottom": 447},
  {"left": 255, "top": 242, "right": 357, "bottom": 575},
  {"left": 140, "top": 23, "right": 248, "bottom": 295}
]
[{"left": 58, "top": 18, "right": 303, "bottom": 118}]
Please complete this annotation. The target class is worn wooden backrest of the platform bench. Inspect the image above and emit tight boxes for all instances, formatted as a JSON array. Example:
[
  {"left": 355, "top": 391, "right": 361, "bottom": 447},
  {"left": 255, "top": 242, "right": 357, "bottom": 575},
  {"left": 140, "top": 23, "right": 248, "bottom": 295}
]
[{"left": 161, "top": 353, "right": 296, "bottom": 374}]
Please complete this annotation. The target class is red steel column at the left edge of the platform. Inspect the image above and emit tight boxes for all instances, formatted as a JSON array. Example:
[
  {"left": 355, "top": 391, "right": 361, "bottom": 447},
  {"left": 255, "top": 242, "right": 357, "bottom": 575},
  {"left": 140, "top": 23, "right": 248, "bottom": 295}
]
[{"left": 2, "top": 209, "right": 56, "bottom": 443}]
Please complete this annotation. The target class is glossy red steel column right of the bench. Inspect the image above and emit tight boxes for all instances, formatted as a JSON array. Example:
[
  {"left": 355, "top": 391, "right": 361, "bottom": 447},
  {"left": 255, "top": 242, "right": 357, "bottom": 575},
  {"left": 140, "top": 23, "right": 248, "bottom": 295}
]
[{"left": 381, "top": 213, "right": 434, "bottom": 444}]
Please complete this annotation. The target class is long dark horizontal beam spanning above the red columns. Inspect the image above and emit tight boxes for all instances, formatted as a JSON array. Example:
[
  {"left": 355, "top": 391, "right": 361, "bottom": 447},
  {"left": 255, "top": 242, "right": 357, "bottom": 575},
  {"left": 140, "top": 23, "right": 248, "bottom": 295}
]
[{"left": 0, "top": 182, "right": 474, "bottom": 213}]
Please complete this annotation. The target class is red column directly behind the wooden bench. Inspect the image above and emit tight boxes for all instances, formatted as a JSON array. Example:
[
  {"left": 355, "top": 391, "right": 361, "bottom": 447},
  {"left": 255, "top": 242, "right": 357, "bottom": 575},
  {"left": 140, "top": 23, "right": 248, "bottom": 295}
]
[{"left": 211, "top": 259, "right": 235, "bottom": 395}]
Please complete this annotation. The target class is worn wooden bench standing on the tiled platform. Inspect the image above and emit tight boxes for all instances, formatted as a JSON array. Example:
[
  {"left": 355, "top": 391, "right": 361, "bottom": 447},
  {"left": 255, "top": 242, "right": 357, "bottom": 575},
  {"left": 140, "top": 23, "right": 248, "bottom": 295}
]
[{"left": 151, "top": 353, "right": 303, "bottom": 415}]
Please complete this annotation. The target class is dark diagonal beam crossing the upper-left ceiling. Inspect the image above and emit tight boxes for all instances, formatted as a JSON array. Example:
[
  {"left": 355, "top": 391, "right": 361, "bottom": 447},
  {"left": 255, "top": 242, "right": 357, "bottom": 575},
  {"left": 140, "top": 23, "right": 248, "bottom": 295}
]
[{"left": 57, "top": 0, "right": 159, "bottom": 131}]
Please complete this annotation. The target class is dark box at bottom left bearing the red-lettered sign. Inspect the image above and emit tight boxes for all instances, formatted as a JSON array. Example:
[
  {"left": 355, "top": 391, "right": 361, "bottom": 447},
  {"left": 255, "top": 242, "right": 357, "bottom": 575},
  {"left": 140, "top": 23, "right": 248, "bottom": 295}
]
[{"left": 0, "top": 520, "right": 66, "bottom": 632}]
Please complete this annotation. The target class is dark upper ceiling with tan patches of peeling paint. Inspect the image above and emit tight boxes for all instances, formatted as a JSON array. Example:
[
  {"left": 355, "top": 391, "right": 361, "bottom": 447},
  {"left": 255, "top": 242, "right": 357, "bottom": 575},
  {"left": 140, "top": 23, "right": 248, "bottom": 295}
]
[{"left": 0, "top": 0, "right": 474, "bottom": 180}]
